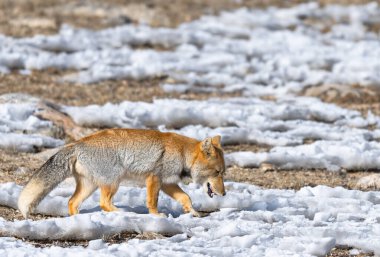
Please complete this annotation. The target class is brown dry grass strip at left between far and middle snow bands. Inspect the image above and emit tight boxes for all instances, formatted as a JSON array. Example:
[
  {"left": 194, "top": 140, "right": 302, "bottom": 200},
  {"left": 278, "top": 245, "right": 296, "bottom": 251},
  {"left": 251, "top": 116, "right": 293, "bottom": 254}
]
[{"left": 0, "top": 69, "right": 240, "bottom": 106}]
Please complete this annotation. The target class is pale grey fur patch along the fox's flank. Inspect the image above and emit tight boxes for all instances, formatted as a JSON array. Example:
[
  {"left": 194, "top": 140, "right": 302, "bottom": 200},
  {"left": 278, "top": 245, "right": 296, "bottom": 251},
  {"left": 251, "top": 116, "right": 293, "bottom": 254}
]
[{"left": 75, "top": 140, "right": 183, "bottom": 185}]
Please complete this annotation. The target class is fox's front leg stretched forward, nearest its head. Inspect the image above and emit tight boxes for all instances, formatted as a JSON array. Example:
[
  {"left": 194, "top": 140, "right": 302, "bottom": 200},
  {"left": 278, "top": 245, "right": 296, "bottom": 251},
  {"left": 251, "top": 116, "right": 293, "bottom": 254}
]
[{"left": 162, "top": 184, "right": 204, "bottom": 217}]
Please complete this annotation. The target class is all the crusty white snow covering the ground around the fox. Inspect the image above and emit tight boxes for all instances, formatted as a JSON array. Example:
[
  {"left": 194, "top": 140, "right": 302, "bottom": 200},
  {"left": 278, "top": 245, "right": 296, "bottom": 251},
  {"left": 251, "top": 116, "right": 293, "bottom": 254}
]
[{"left": 0, "top": 3, "right": 380, "bottom": 256}]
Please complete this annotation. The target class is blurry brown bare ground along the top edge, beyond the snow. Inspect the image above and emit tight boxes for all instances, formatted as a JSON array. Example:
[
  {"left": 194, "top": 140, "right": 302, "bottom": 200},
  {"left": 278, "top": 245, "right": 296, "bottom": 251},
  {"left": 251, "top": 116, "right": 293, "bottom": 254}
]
[{"left": 0, "top": 0, "right": 370, "bottom": 37}]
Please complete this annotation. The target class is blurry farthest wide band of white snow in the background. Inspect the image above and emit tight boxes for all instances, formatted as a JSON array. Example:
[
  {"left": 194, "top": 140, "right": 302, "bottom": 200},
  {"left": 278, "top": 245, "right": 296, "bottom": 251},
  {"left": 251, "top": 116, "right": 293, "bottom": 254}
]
[{"left": 0, "top": 3, "right": 380, "bottom": 96}]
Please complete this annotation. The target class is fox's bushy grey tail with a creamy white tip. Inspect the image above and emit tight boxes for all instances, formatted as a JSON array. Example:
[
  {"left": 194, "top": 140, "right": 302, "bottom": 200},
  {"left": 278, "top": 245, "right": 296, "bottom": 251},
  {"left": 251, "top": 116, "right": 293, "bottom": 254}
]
[{"left": 18, "top": 145, "right": 75, "bottom": 218}]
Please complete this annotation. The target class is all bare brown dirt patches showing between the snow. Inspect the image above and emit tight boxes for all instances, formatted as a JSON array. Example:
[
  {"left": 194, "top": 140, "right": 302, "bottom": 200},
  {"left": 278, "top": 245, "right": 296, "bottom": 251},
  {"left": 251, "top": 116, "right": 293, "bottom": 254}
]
[{"left": 0, "top": 0, "right": 380, "bottom": 253}]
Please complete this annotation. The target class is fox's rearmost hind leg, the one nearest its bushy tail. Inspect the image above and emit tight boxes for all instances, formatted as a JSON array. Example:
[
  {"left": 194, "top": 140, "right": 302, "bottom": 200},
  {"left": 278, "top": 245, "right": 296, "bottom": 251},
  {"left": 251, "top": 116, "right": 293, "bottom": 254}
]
[{"left": 69, "top": 175, "right": 97, "bottom": 215}]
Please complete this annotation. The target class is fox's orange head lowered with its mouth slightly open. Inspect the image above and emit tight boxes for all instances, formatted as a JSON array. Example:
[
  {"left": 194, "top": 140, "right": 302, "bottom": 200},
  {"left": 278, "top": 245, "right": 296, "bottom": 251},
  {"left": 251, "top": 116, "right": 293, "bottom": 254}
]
[{"left": 191, "top": 136, "right": 226, "bottom": 197}]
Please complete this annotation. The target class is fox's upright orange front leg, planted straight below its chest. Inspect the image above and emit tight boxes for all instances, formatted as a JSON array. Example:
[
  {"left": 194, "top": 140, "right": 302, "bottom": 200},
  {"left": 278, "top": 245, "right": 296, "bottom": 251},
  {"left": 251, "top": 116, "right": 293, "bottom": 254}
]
[{"left": 145, "top": 175, "right": 166, "bottom": 217}]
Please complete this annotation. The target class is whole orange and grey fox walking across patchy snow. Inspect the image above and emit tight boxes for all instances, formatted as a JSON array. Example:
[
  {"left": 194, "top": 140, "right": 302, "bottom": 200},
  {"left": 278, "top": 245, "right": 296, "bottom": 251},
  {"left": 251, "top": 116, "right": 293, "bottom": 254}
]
[{"left": 18, "top": 129, "right": 226, "bottom": 218}]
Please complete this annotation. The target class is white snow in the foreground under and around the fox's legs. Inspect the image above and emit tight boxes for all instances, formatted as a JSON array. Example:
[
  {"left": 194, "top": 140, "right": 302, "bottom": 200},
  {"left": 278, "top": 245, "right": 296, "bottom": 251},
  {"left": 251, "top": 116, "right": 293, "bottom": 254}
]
[{"left": 0, "top": 180, "right": 380, "bottom": 256}]
